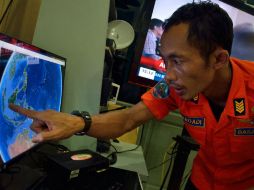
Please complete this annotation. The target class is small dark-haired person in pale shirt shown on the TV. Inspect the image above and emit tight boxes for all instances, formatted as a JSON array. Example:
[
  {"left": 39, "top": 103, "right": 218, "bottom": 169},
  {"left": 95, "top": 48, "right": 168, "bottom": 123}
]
[{"left": 142, "top": 18, "right": 163, "bottom": 59}]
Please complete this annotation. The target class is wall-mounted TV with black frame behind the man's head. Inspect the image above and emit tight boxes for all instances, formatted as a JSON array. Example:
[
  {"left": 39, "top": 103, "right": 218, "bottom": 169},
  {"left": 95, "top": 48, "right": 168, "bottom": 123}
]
[{"left": 129, "top": 0, "right": 254, "bottom": 87}]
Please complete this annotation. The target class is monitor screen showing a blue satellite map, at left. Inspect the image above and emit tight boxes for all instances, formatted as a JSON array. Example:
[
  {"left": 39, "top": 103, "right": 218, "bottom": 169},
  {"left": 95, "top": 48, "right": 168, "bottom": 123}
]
[{"left": 0, "top": 34, "right": 66, "bottom": 165}]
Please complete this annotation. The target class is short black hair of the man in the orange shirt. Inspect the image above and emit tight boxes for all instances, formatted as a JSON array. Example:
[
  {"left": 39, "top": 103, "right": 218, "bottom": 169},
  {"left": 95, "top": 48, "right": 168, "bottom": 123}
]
[{"left": 164, "top": 1, "right": 233, "bottom": 60}]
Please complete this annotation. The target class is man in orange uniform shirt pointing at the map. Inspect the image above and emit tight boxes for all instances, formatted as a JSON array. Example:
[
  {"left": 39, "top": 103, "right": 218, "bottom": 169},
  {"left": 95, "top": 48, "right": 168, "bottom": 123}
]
[{"left": 10, "top": 2, "right": 254, "bottom": 190}]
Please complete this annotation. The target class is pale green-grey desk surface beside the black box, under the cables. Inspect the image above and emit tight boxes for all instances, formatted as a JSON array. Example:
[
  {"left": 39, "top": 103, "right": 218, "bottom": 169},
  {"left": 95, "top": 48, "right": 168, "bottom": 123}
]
[{"left": 103, "top": 142, "right": 148, "bottom": 180}]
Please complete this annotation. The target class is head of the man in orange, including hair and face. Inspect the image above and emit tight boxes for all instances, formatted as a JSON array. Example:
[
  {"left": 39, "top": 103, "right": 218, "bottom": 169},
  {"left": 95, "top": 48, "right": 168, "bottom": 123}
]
[{"left": 161, "top": 2, "right": 233, "bottom": 100}]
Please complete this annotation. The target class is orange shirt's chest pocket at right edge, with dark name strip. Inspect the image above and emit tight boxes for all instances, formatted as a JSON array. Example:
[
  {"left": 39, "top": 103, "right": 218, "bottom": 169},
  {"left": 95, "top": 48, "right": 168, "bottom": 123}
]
[{"left": 229, "top": 119, "right": 254, "bottom": 162}]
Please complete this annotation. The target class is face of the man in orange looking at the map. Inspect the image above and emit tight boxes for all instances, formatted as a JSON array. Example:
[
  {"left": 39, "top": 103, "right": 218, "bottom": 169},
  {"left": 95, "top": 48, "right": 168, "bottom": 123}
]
[{"left": 161, "top": 23, "right": 215, "bottom": 100}]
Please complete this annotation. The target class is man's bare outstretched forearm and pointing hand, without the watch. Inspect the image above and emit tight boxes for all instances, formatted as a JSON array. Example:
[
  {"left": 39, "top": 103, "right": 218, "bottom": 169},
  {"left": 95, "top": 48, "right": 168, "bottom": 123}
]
[{"left": 9, "top": 102, "right": 153, "bottom": 142}]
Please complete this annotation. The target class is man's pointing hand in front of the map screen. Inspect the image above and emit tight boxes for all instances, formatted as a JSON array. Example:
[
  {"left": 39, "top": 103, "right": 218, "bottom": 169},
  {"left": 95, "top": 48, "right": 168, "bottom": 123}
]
[{"left": 9, "top": 104, "right": 84, "bottom": 143}]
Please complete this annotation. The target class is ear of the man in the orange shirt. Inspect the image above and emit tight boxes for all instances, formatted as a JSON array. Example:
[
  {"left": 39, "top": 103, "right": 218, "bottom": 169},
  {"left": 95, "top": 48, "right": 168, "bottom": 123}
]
[{"left": 213, "top": 48, "right": 229, "bottom": 69}]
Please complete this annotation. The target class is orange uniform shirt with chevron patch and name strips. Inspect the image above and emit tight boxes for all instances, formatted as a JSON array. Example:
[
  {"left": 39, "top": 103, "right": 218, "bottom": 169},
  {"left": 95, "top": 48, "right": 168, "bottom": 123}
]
[{"left": 142, "top": 58, "right": 254, "bottom": 190}]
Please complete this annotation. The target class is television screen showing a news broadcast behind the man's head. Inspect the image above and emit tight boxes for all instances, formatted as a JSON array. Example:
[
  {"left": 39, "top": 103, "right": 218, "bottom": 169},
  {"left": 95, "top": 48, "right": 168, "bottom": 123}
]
[{"left": 129, "top": 0, "right": 254, "bottom": 87}]
